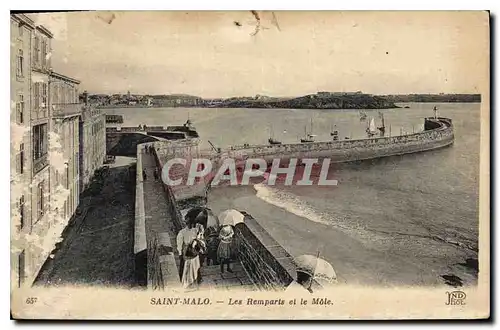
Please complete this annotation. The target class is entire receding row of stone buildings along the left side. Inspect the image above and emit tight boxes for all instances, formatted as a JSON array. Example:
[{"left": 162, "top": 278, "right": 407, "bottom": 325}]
[{"left": 10, "top": 14, "right": 106, "bottom": 287}]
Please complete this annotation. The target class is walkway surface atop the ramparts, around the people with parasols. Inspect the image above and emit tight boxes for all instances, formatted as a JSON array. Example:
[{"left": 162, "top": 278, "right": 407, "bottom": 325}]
[{"left": 142, "top": 151, "right": 256, "bottom": 291}]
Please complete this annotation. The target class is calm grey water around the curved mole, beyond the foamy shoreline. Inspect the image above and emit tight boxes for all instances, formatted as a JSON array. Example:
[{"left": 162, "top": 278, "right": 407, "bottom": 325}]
[{"left": 105, "top": 103, "right": 480, "bottom": 284}]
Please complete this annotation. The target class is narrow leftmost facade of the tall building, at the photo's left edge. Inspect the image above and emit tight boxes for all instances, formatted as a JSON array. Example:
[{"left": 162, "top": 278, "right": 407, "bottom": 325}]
[{"left": 10, "top": 15, "right": 34, "bottom": 286}]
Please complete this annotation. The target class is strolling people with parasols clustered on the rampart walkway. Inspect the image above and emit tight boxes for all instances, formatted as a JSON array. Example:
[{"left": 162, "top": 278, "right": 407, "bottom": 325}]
[{"left": 177, "top": 207, "right": 236, "bottom": 289}]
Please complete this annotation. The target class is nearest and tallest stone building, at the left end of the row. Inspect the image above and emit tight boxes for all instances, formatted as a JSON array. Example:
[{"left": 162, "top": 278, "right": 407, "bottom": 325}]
[{"left": 10, "top": 14, "right": 53, "bottom": 286}]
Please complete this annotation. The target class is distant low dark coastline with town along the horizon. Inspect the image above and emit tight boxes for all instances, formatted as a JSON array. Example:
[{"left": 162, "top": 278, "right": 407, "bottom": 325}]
[{"left": 80, "top": 91, "right": 481, "bottom": 109}]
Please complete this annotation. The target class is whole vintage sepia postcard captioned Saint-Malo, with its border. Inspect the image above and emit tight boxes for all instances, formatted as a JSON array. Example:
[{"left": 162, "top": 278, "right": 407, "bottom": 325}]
[{"left": 10, "top": 10, "right": 490, "bottom": 320}]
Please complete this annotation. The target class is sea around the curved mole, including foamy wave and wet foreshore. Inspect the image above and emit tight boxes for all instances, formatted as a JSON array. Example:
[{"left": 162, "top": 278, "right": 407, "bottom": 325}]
[{"left": 104, "top": 103, "right": 480, "bottom": 286}]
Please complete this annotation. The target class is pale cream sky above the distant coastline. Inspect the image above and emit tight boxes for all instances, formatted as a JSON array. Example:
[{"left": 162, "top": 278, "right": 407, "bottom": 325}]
[{"left": 32, "top": 11, "right": 489, "bottom": 97}]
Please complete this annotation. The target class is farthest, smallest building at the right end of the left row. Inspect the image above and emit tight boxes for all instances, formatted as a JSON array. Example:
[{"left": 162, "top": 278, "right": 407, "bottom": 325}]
[{"left": 79, "top": 93, "right": 106, "bottom": 191}]
